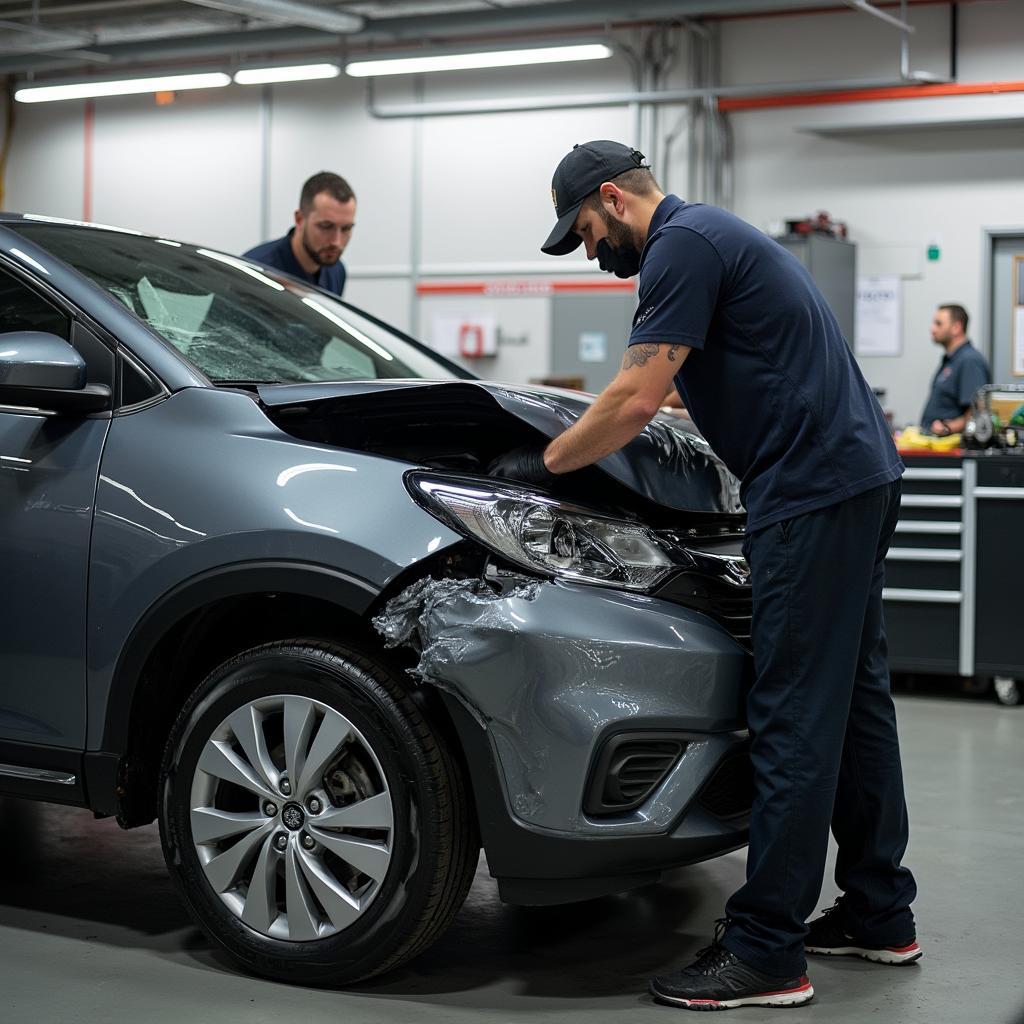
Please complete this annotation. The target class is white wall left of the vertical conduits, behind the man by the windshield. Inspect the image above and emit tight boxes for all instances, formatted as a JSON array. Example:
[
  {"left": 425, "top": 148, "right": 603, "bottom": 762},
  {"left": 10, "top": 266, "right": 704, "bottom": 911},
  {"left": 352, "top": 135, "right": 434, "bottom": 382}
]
[{"left": 5, "top": 58, "right": 631, "bottom": 356}]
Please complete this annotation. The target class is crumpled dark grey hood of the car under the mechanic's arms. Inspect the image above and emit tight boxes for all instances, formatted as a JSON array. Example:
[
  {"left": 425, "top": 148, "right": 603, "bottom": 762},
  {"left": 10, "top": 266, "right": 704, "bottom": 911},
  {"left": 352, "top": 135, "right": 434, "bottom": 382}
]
[{"left": 257, "top": 380, "right": 743, "bottom": 515}]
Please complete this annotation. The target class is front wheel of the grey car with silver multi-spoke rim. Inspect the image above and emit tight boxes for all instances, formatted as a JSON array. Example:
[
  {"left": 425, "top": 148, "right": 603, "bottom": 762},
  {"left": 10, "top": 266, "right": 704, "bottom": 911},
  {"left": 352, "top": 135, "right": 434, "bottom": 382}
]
[{"left": 160, "top": 641, "right": 479, "bottom": 984}]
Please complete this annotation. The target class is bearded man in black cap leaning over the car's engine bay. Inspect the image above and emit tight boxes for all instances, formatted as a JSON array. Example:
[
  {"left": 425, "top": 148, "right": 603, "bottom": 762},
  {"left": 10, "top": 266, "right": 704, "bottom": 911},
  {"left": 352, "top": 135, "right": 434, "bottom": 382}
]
[{"left": 492, "top": 141, "right": 921, "bottom": 1009}]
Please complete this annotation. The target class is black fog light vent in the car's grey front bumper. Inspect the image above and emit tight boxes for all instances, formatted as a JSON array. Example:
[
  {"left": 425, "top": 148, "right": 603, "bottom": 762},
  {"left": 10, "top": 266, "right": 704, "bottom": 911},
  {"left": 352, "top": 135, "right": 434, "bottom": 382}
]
[{"left": 583, "top": 732, "right": 686, "bottom": 815}]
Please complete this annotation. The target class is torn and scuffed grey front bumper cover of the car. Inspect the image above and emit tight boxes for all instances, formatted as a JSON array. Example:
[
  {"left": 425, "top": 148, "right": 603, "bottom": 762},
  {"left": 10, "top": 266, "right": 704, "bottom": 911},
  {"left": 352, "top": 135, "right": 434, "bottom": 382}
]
[{"left": 374, "top": 577, "right": 746, "bottom": 835}]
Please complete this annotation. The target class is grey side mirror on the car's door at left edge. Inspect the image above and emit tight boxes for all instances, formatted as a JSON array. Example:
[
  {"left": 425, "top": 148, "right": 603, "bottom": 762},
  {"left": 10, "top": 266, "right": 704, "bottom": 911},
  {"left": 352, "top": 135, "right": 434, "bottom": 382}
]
[{"left": 0, "top": 331, "right": 111, "bottom": 413}]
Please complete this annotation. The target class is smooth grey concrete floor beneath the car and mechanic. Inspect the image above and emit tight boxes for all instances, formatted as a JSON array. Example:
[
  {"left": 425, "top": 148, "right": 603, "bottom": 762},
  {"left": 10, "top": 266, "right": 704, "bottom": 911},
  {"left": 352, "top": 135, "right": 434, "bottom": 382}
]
[{"left": 0, "top": 696, "right": 1024, "bottom": 1024}]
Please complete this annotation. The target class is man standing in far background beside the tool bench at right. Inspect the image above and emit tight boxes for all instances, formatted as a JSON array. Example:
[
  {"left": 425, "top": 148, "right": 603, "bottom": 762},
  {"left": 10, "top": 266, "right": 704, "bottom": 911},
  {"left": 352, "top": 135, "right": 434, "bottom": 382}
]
[{"left": 921, "top": 304, "right": 992, "bottom": 437}]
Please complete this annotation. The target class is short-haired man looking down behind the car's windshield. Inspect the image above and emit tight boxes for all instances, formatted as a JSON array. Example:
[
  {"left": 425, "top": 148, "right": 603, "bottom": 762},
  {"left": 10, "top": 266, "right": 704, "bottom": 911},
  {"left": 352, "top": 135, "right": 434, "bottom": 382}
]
[{"left": 244, "top": 171, "right": 355, "bottom": 297}]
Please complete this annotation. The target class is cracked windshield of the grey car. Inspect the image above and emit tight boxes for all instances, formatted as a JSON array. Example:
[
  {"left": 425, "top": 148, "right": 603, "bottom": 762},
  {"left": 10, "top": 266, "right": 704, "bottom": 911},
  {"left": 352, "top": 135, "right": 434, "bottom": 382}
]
[{"left": 16, "top": 222, "right": 472, "bottom": 383}]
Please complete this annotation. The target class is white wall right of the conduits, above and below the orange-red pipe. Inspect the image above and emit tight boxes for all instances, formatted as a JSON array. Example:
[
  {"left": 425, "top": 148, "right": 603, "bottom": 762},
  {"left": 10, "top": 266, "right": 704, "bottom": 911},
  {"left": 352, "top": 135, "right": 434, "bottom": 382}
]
[{"left": 723, "top": 3, "right": 1024, "bottom": 423}]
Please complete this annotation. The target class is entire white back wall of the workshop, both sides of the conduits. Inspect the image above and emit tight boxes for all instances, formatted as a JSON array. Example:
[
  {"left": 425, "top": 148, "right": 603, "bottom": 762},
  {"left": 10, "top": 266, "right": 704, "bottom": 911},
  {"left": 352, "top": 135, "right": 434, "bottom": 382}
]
[{"left": 4, "top": 0, "right": 1024, "bottom": 411}]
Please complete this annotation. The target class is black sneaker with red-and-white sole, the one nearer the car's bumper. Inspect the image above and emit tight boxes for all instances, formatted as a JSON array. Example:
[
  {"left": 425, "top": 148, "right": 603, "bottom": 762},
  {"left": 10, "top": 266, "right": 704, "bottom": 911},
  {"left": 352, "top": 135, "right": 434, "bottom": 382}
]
[{"left": 648, "top": 919, "right": 814, "bottom": 1010}]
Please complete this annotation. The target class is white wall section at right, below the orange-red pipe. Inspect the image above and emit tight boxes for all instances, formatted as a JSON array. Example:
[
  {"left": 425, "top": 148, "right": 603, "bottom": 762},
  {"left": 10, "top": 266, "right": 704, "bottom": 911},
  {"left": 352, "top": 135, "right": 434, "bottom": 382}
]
[{"left": 734, "top": 112, "right": 1024, "bottom": 423}]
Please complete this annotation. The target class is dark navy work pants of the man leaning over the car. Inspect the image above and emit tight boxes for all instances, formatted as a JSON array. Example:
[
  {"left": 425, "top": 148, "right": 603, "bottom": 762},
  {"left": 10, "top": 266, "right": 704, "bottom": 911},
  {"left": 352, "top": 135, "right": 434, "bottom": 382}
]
[{"left": 723, "top": 480, "right": 916, "bottom": 978}]
